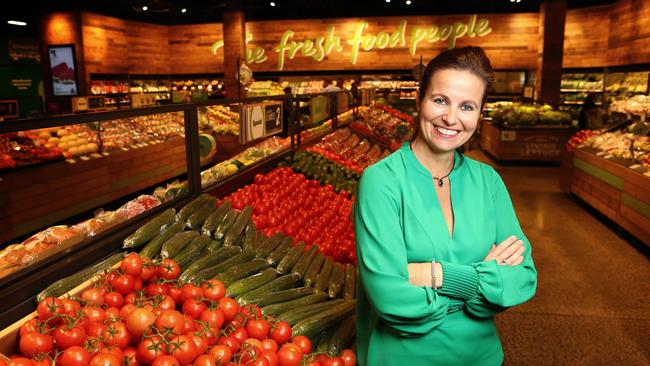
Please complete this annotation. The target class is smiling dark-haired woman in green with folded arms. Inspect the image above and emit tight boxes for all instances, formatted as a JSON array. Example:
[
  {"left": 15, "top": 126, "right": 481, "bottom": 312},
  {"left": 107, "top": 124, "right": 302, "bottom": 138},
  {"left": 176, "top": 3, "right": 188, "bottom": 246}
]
[{"left": 355, "top": 47, "right": 537, "bottom": 366}]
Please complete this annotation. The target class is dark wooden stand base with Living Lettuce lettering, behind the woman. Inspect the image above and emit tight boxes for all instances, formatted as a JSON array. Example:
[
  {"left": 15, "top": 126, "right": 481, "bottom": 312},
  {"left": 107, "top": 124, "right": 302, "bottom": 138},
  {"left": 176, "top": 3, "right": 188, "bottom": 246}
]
[{"left": 481, "top": 121, "right": 573, "bottom": 164}]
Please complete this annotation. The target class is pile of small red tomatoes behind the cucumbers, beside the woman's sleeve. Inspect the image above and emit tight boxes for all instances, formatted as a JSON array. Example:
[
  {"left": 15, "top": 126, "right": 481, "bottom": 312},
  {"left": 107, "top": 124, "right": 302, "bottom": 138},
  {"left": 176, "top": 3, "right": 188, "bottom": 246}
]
[{"left": 224, "top": 167, "right": 357, "bottom": 264}]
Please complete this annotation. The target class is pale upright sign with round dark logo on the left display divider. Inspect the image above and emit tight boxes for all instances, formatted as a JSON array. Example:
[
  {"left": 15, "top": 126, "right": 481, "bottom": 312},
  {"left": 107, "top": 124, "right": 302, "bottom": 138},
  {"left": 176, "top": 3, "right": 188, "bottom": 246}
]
[{"left": 239, "top": 102, "right": 283, "bottom": 144}]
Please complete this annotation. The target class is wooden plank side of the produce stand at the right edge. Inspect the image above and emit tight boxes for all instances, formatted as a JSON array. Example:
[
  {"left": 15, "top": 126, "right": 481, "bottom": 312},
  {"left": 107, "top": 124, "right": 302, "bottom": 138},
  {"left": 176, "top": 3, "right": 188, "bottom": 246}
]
[{"left": 560, "top": 149, "right": 650, "bottom": 246}]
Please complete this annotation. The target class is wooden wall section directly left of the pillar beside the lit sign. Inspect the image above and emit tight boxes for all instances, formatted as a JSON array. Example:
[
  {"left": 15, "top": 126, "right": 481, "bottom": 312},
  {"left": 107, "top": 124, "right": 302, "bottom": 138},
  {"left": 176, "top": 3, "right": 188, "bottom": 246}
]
[{"left": 168, "top": 23, "right": 223, "bottom": 74}]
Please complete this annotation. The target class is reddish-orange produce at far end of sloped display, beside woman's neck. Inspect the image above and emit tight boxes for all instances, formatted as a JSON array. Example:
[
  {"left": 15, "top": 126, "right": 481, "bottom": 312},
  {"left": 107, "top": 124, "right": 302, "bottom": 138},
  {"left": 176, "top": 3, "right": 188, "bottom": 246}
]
[{"left": 350, "top": 103, "right": 415, "bottom": 151}]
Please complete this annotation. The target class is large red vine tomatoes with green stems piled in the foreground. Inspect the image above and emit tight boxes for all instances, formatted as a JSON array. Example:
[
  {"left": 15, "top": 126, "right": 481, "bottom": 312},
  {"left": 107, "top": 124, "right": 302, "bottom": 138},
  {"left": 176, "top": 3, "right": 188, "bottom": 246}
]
[{"left": 0, "top": 253, "right": 356, "bottom": 366}]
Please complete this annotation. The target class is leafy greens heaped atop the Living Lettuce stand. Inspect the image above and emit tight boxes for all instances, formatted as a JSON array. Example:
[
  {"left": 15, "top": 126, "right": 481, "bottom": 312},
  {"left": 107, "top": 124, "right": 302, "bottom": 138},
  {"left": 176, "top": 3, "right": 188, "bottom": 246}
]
[{"left": 486, "top": 102, "right": 571, "bottom": 126}]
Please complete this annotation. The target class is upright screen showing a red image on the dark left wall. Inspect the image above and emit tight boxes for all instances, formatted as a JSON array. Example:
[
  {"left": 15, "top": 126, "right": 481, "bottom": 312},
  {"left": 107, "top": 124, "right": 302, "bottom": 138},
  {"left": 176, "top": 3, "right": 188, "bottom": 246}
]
[{"left": 47, "top": 45, "right": 78, "bottom": 96}]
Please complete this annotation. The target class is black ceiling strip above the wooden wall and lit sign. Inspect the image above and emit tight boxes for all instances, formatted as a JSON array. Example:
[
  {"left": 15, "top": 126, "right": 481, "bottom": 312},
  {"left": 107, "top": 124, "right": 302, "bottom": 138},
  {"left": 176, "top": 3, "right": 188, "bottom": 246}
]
[{"left": 0, "top": 0, "right": 615, "bottom": 35}]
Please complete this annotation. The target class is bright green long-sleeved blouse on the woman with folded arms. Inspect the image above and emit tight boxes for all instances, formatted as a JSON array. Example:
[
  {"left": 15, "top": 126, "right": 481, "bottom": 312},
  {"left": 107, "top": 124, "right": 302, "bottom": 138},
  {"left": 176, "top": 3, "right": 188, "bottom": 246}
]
[{"left": 354, "top": 143, "right": 537, "bottom": 366}]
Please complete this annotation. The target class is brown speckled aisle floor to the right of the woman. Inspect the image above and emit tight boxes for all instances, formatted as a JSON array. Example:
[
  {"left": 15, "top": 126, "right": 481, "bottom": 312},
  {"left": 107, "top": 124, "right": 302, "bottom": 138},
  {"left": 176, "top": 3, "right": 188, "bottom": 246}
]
[{"left": 467, "top": 150, "right": 650, "bottom": 366}]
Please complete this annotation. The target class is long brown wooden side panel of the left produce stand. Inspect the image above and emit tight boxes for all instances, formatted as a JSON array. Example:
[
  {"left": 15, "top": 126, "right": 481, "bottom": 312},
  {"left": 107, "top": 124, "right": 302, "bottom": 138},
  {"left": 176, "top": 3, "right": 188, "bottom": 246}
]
[{"left": 0, "top": 137, "right": 187, "bottom": 242}]
